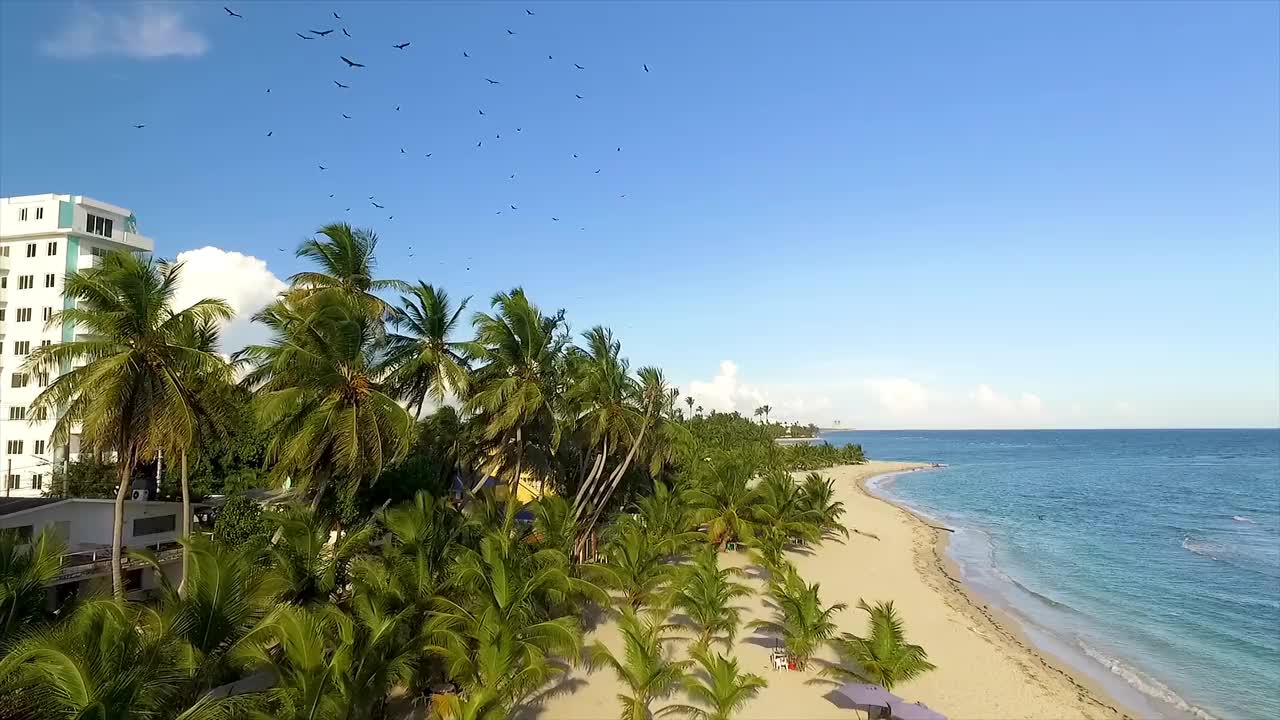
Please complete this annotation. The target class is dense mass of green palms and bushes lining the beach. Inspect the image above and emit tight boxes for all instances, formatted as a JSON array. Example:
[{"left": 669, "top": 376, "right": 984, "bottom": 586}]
[{"left": 0, "top": 224, "right": 927, "bottom": 720}]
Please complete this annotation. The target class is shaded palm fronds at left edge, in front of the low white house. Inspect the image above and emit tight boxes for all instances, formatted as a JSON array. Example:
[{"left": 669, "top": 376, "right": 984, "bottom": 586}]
[{"left": 0, "top": 527, "right": 65, "bottom": 638}]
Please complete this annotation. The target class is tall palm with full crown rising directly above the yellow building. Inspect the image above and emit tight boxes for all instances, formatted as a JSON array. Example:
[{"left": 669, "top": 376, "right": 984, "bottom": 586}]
[{"left": 466, "top": 287, "right": 568, "bottom": 498}]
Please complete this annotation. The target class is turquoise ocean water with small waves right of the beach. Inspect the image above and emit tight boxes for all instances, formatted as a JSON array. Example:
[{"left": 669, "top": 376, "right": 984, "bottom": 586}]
[{"left": 824, "top": 430, "right": 1280, "bottom": 719}]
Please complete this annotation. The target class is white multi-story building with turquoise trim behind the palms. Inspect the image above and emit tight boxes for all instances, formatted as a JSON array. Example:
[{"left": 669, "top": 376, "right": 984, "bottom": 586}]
[{"left": 0, "top": 193, "right": 155, "bottom": 497}]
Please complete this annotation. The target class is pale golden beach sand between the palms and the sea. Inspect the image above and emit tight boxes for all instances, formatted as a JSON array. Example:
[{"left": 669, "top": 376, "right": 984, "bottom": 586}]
[{"left": 516, "top": 462, "right": 1128, "bottom": 720}]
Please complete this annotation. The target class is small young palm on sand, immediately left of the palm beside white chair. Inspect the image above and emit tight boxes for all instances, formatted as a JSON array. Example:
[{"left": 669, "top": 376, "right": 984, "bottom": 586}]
[{"left": 672, "top": 547, "right": 751, "bottom": 648}]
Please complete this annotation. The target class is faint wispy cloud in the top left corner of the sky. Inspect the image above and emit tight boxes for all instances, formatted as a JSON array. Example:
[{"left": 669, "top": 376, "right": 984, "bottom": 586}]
[{"left": 41, "top": 3, "right": 209, "bottom": 60}]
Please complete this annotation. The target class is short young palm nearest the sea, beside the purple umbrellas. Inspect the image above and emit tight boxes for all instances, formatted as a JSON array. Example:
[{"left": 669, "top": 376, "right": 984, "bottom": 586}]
[{"left": 823, "top": 601, "right": 934, "bottom": 691}]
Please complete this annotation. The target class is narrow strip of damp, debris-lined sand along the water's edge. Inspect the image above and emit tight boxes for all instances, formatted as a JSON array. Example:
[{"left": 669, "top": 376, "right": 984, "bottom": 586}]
[{"left": 860, "top": 464, "right": 1144, "bottom": 720}]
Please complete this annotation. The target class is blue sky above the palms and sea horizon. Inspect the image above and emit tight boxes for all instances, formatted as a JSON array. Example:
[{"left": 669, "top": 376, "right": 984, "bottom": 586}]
[{"left": 0, "top": 1, "right": 1280, "bottom": 428}]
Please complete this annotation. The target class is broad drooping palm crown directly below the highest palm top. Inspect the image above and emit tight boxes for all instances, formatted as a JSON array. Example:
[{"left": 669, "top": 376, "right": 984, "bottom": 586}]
[{"left": 237, "top": 295, "right": 413, "bottom": 507}]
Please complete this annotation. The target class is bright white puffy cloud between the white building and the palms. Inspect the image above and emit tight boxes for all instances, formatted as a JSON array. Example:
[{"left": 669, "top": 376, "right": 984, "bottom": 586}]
[{"left": 174, "top": 246, "right": 285, "bottom": 352}]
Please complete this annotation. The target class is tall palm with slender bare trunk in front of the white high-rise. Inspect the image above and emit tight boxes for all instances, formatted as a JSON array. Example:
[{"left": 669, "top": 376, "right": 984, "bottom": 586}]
[{"left": 23, "top": 252, "right": 232, "bottom": 598}]
